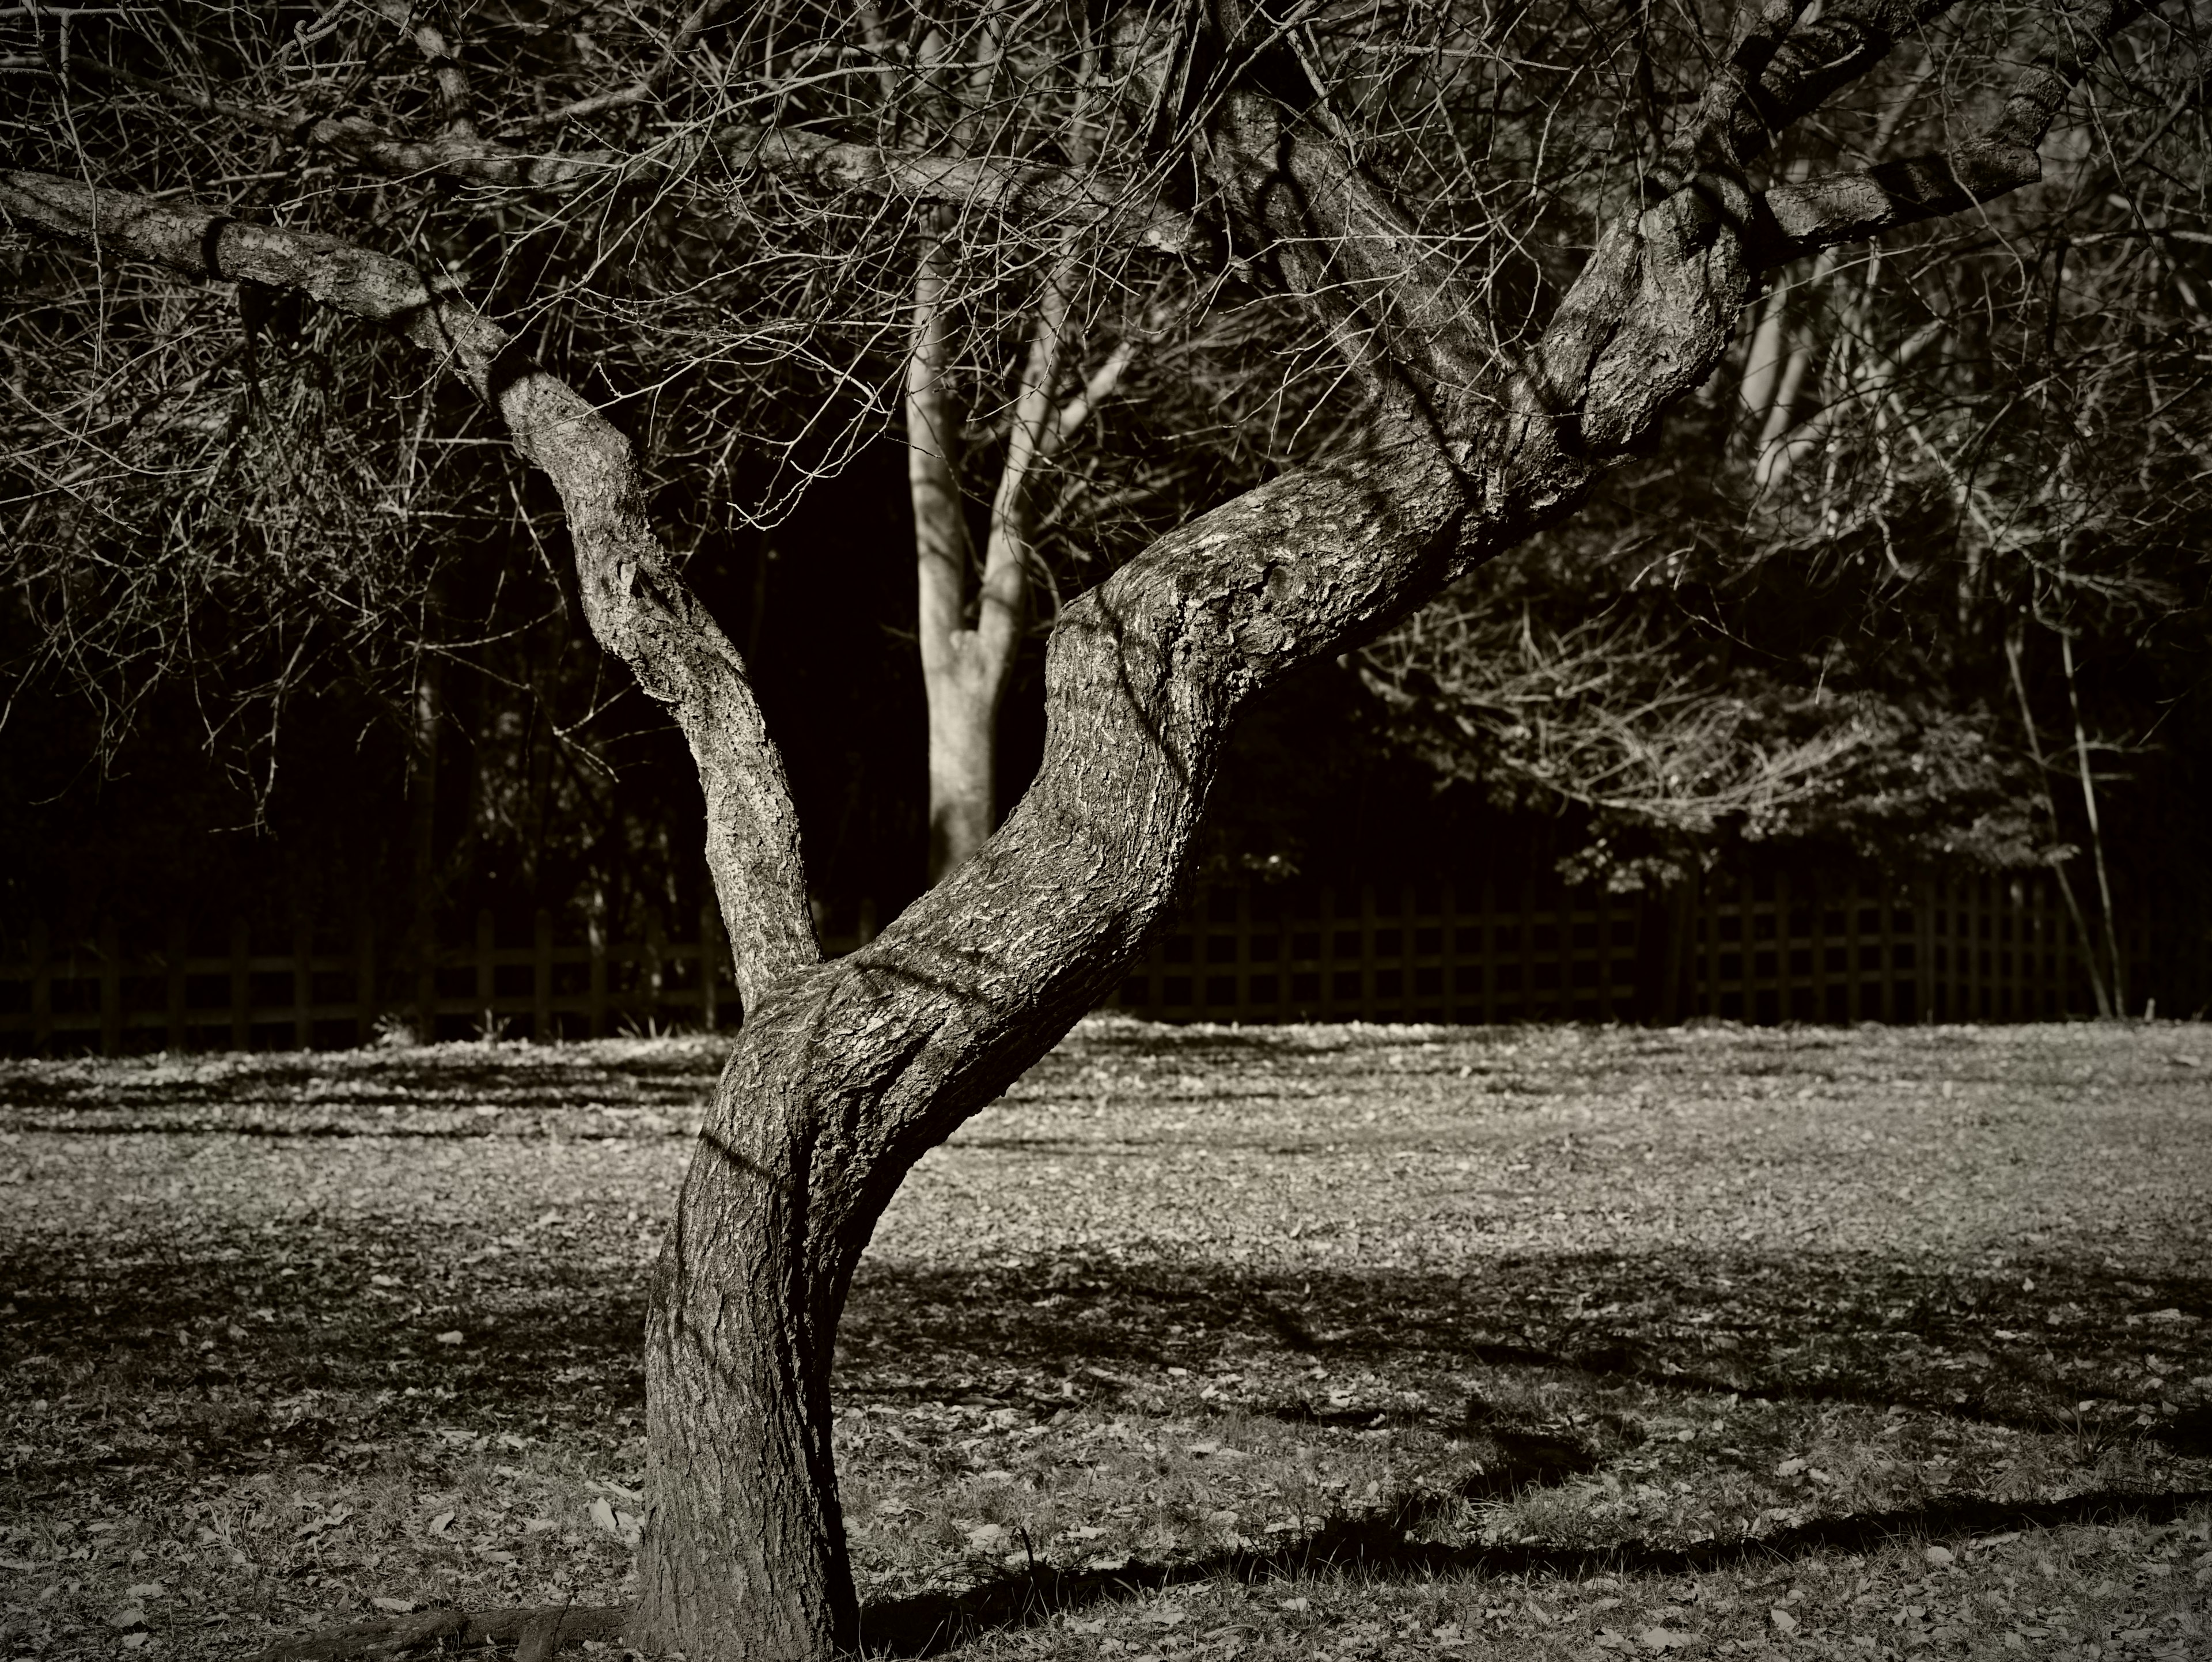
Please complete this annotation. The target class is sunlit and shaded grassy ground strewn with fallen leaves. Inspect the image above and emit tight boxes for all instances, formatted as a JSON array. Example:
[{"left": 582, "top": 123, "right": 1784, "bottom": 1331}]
[{"left": 0, "top": 1020, "right": 2212, "bottom": 1662}]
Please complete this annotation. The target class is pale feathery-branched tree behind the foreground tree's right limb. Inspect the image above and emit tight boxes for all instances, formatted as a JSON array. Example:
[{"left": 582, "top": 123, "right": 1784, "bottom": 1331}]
[{"left": 1362, "top": 40, "right": 2212, "bottom": 1012}]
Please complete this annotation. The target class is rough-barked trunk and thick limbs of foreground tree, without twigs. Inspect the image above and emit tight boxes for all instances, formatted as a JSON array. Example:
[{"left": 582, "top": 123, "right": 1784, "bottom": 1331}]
[{"left": 0, "top": 0, "right": 2133, "bottom": 1662}]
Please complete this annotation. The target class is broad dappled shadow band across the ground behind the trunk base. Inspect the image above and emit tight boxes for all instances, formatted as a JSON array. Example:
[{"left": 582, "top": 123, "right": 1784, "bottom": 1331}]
[{"left": 0, "top": 1235, "right": 2212, "bottom": 1487}]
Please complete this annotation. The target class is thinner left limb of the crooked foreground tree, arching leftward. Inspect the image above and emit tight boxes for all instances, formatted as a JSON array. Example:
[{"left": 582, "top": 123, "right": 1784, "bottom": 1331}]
[{"left": 0, "top": 173, "right": 821, "bottom": 1009}]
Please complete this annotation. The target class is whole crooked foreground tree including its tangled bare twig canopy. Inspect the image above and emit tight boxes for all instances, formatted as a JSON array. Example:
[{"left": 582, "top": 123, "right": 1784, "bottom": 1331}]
[{"left": 0, "top": 0, "right": 2196, "bottom": 1662}]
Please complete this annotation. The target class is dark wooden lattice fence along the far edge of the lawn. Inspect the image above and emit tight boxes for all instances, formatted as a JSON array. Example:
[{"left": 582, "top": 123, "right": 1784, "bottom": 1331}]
[{"left": 0, "top": 876, "right": 2186, "bottom": 1055}]
